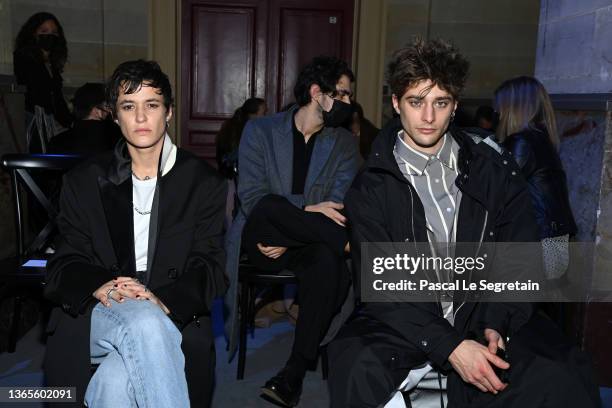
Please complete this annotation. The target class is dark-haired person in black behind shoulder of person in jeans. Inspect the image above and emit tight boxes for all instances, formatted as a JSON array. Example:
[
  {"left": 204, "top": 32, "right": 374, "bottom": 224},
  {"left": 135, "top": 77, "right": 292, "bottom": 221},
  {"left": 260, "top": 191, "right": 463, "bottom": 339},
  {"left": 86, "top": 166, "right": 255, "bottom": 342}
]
[{"left": 47, "top": 82, "right": 122, "bottom": 156}]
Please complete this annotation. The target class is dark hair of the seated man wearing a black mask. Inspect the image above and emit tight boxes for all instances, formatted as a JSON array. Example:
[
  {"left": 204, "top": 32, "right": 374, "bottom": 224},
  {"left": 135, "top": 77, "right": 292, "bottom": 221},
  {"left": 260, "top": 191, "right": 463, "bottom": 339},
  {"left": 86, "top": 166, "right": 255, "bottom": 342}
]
[{"left": 293, "top": 56, "right": 355, "bottom": 106}]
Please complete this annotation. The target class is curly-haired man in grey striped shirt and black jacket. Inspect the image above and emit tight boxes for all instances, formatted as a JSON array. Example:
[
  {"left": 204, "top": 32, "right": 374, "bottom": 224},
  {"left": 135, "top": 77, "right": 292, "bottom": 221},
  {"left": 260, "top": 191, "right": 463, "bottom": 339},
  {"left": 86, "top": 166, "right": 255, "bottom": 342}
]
[{"left": 329, "top": 40, "right": 538, "bottom": 407}]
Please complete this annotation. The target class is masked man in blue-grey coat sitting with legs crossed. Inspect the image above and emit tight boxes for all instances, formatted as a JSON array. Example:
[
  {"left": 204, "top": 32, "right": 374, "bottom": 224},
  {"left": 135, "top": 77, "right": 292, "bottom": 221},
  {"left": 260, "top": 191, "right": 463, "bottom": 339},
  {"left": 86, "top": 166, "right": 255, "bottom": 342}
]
[{"left": 226, "top": 57, "right": 360, "bottom": 407}]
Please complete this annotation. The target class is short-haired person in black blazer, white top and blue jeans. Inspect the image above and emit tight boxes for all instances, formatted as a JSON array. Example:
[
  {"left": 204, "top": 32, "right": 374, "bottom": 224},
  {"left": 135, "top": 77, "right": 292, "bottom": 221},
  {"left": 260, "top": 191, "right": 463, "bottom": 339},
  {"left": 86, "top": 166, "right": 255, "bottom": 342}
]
[{"left": 45, "top": 60, "right": 227, "bottom": 408}]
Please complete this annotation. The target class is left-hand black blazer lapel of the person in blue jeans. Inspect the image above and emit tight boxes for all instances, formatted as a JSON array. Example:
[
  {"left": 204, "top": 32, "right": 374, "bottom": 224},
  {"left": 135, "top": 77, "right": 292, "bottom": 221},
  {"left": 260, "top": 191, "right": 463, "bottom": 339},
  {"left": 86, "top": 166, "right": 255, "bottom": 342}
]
[{"left": 98, "top": 177, "right": 136, "bottom": 276}]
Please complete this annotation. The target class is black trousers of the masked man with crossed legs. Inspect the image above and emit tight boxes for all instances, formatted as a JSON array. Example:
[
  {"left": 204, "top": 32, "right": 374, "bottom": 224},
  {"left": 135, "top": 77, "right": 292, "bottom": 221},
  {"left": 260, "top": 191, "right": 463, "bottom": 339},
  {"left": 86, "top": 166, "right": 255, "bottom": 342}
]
[{"left": 242, "top": 195, "right": 350, "bottom": 361}]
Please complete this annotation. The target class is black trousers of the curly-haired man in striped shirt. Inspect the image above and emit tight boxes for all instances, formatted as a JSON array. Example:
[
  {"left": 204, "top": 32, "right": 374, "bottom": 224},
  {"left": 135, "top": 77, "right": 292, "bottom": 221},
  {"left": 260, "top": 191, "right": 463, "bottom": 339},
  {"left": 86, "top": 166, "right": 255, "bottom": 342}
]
[{"left": 327, "top": 315, "right": 601, "bottom": 408}]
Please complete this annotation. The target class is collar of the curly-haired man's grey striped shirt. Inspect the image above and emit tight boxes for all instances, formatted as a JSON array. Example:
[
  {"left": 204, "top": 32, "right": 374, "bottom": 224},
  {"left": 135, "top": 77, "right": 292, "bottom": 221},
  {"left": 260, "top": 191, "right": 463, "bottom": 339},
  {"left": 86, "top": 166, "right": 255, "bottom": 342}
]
[{"left": 395, "top": 130, "right": 458, "bottom": 176}]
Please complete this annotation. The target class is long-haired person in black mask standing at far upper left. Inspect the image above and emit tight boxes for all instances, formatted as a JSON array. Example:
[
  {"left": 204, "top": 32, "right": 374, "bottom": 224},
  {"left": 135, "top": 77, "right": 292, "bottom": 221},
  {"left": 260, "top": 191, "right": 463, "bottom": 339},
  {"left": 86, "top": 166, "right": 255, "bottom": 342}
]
[{"left": 13, "top": 12, "right": 73, "bottom": 152}]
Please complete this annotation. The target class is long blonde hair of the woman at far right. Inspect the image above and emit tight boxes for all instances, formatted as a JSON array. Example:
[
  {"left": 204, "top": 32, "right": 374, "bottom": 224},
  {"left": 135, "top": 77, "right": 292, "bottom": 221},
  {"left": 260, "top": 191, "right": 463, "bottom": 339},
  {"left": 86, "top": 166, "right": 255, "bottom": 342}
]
[{"left": 494, "top": 76, "right": 559, "bottom": 148}]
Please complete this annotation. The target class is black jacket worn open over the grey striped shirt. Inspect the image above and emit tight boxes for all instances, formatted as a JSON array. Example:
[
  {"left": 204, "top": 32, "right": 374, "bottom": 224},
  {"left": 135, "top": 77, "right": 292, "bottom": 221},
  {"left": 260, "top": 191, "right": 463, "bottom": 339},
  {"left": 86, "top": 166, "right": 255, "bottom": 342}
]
[{"left": 345, "top": 119, "right": 538, "bottom": 369}]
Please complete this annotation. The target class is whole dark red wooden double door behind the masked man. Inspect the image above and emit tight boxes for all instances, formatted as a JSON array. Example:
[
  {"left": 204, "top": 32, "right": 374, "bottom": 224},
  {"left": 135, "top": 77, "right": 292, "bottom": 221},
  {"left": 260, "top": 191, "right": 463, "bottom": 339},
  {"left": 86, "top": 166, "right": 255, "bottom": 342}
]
[{"left": 181, "top": 0, "right": 354, "bottom": 162}]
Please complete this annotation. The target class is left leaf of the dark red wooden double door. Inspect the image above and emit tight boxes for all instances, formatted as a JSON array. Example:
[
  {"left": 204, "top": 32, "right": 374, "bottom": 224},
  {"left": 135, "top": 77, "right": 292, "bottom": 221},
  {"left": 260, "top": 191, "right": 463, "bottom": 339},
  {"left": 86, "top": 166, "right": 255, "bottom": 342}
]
[{"left": 181, "top": 0, "right": 268, "bottom": 162}]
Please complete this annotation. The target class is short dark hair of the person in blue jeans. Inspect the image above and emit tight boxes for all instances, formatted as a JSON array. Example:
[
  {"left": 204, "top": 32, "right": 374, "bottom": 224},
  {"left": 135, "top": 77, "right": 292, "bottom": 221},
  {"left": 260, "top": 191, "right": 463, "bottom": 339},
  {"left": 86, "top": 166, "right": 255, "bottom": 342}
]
[{"left": 106, "top": 59, "right": 173, "bottom": 114}]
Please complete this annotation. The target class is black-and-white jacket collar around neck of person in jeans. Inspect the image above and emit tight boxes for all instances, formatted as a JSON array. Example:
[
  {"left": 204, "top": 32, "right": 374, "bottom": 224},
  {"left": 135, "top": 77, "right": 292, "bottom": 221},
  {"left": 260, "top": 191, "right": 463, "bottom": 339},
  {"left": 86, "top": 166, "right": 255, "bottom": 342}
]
[{"left": 106, "top": 133, "right": 177, "bottom": 185}]
